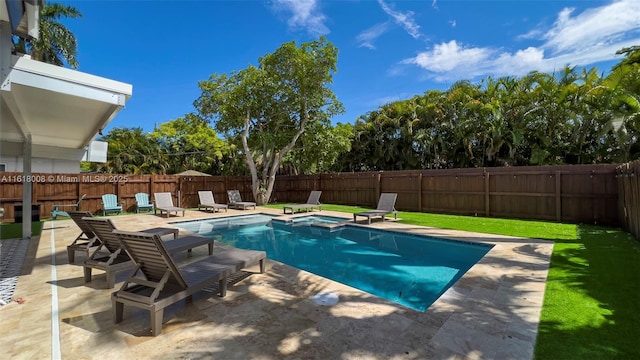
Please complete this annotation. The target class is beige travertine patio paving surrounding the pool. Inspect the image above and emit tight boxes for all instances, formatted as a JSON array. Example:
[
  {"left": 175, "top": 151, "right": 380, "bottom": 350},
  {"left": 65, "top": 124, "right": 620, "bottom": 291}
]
[{"left": 0, "top": 207, "right": 553, "bottom": 359}]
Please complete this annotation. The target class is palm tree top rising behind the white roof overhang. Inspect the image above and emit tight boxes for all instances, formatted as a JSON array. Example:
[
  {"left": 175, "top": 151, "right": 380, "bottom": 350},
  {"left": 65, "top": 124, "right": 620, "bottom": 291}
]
[{"left": 14, "top": 3, "right": 82, "bottom": 69}]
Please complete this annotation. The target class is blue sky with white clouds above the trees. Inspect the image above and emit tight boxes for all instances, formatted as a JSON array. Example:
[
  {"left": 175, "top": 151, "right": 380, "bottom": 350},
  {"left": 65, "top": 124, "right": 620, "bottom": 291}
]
[{"left": 63, "top": 0, "right": 640, "bottom": 131}]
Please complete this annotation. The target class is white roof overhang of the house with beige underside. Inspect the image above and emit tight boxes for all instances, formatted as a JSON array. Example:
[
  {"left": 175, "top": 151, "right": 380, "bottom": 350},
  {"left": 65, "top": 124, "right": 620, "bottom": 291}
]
[{"left": 0, "top": 56, "right": 133, "bottom": 149}]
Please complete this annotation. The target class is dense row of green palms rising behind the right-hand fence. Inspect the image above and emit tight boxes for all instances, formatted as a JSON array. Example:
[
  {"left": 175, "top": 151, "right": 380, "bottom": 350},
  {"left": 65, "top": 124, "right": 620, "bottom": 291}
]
[{"left": 336, "top": 54, "right": 640, "bottom": 171}]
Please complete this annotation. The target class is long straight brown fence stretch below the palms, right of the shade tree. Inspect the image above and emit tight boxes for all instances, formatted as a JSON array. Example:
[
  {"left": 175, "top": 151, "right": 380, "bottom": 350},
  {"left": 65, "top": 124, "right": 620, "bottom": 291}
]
[{"left": 275, "top": 165, "right": 620, "bottom": 226}]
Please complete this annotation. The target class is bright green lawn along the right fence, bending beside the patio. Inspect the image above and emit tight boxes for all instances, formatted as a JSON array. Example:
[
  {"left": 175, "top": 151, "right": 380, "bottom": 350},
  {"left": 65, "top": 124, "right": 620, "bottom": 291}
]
[{"left": 267, "top": 204, "right": 640, "bottom": 360}]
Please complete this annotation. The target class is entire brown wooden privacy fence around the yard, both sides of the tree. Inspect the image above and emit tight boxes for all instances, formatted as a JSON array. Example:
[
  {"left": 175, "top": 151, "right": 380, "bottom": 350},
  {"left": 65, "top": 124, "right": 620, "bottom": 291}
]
[{"left": 0, "top": 164, "right": 638, "bottom": 226}]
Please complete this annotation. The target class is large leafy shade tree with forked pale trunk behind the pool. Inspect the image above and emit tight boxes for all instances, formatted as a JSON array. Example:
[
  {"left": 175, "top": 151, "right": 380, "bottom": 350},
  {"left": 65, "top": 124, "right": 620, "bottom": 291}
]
[{"left": 194, "top": 37, "right": 344, "bottom": 204}]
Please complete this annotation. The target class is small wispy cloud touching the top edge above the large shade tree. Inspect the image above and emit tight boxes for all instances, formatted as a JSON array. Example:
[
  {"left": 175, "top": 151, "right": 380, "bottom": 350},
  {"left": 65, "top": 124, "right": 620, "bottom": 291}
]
[{"left": 273, "top": 0, "right": 330, "bottom": 35}]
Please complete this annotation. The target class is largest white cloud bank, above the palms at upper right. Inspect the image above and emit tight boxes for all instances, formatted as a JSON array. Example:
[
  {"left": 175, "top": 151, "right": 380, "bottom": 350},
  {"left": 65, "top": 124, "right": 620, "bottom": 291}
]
[{"left": 402, "top": 0, "right": 640, "bottom": 81}]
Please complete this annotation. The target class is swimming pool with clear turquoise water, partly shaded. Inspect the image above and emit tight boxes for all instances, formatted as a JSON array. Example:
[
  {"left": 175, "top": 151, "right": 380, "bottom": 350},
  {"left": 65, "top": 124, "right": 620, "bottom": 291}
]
[{"left": 174, "top": 214, "right": 491, "bottom": 311}]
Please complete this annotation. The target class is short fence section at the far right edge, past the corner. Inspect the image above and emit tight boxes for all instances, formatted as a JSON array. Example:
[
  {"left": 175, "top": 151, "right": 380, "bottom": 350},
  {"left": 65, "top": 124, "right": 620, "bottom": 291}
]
[{"left": 616, "top": 160, "right": 640, "bottom": 239}]
